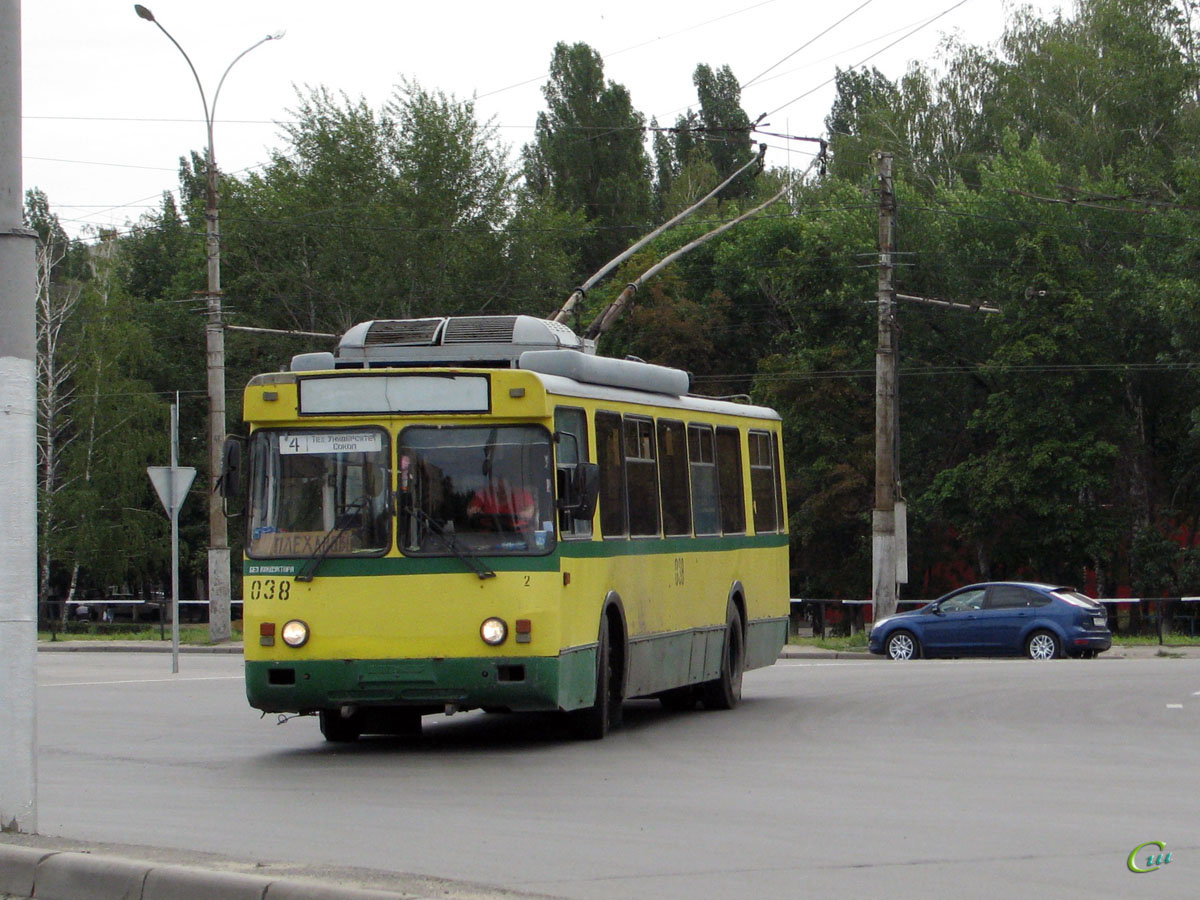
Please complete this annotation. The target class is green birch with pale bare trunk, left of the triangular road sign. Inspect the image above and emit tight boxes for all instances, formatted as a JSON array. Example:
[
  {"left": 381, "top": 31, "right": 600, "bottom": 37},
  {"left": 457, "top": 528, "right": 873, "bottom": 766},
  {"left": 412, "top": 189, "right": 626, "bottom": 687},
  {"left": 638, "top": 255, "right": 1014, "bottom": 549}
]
[{"left": 26, "top": 200, "right": 164, "bottom": 608}]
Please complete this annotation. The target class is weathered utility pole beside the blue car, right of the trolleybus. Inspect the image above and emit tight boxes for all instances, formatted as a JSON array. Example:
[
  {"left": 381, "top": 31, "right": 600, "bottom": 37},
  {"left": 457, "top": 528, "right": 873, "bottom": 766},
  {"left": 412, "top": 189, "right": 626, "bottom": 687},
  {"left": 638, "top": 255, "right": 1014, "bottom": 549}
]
[{"left": 871, "top": 151, "right": 898, "bottom": 622}]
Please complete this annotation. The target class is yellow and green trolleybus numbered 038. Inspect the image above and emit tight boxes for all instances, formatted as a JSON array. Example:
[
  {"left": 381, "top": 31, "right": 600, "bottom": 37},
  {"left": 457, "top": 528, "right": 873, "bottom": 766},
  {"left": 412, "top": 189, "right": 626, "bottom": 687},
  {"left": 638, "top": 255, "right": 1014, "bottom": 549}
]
[{"left": 227, "top": 316, "right": 788, "bottom": 742}]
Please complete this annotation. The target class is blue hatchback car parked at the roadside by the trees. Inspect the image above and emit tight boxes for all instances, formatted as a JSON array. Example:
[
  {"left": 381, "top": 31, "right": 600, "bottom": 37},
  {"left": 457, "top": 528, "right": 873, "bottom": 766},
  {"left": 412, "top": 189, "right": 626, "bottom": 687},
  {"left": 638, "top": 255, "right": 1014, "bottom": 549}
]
[{"left": 869, "top": 581, "right": 1112, "bottom": 660}]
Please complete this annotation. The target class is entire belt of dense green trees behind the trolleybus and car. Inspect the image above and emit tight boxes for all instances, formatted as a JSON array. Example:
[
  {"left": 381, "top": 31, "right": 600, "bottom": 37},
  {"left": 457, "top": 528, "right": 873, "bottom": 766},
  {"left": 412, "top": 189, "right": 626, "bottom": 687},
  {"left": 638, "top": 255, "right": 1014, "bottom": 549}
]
[{"left": 28, "top": 0, "right": 1200, "bottom": 607}]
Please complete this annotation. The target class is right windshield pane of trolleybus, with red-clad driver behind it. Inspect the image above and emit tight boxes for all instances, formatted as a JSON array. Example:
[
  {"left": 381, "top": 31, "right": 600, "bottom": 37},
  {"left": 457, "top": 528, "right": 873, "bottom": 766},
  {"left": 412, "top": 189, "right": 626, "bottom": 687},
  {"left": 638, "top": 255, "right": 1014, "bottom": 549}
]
[{"left": 397, "top": 425, "right": 554, "bottom": 556}]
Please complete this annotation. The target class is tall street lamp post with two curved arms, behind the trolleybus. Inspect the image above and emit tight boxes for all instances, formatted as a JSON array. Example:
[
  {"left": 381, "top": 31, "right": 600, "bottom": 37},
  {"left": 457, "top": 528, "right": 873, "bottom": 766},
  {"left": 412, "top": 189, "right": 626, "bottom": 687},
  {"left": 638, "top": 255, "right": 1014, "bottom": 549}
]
[{"left": 133, "top": 4, "right": 283, "bottom": 642}]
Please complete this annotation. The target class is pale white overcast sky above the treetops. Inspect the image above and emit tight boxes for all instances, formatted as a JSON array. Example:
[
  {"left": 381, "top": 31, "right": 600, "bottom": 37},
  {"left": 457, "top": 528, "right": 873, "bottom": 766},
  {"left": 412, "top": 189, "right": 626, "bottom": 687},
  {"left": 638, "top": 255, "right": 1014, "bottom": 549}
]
[{"left": 22, "top": 0, "right": 1032, "bottom": 235}]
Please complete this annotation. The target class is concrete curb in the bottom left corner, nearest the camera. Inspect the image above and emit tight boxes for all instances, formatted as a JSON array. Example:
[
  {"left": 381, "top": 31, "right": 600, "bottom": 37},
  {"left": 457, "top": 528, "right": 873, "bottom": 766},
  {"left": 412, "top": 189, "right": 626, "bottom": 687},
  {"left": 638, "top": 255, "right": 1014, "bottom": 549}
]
[{"left": 0, "top": 844, "right": 422, "bottom": 900}]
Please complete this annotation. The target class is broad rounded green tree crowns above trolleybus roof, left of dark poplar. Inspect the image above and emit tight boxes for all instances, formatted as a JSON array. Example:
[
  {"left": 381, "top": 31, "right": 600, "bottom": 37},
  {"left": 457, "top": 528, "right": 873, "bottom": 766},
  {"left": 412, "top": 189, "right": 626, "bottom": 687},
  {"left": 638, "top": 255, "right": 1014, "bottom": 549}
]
[{"left": 223, "top": 83, "right": 572, "bottom": 340}]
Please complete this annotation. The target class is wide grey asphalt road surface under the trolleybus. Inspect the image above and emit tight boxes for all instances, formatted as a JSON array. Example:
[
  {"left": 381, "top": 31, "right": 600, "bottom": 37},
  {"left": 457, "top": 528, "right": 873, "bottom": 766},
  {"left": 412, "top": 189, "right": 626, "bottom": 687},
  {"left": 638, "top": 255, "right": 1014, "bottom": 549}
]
[{"left": 28, "top": 653, "right": 1200, "bottom": 900}]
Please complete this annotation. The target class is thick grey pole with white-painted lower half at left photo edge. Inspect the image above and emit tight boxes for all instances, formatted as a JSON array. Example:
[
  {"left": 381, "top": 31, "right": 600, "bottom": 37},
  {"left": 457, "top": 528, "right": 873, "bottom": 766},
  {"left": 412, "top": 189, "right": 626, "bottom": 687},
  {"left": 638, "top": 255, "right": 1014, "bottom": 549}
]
[{"left": 0, "top": 0, "right": 37, "bottom": 833}]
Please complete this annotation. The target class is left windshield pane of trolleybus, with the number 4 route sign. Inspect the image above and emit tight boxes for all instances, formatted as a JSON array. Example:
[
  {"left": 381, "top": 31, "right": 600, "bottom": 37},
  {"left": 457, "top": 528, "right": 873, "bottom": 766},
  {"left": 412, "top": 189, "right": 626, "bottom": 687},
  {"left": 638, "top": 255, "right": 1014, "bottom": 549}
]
[{"left": 247, "top": 428, "right": 391, "bottom": 558}]
